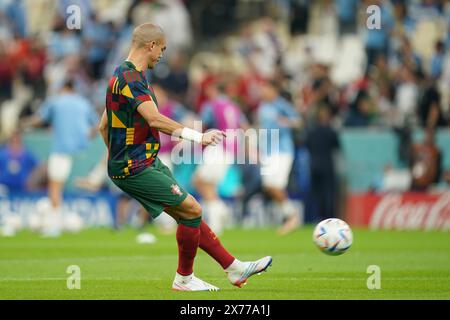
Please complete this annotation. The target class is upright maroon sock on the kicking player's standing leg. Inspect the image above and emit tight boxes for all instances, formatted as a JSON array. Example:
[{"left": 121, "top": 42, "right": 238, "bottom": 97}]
[{"left": 177, "top": 223, "right": 200, "bottom": 276}]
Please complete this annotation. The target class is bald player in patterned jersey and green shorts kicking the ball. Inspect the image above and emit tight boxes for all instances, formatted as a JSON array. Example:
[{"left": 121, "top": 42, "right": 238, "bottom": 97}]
[{"left": 99, "top": 23, "right": 272, "bottom": 291}]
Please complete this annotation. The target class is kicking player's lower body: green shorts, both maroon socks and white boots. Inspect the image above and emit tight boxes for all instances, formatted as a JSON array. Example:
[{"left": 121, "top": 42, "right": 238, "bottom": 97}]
[{"left": 113, "top": 161, "right": 272, "bottom": 291}]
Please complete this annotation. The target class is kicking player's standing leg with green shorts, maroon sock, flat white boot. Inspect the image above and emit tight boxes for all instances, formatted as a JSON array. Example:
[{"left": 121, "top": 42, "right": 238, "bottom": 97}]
[{"left": 112, "top": 168, "right": 214, "bottom": 291}]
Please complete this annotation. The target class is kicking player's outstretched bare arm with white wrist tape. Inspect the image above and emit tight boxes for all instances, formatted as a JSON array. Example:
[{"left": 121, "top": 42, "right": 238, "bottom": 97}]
[{"left": 137, "top": 101, "right": 225, "bottom": 145}]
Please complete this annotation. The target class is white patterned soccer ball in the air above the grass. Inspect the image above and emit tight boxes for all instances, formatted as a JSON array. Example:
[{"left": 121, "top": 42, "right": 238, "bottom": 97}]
[{"left": 313, "top": 218, "right": 353, "bottom": 256}]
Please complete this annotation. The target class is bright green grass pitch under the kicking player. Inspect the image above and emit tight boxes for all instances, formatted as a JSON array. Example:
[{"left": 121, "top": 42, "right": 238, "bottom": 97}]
[{"left": 0, "top": 226, "right": 450, "bottom": 300}]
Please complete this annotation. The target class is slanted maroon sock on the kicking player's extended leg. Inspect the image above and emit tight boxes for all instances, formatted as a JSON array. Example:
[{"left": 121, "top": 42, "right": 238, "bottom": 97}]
[{"left": 199, "top": 220, "right": 234, "bottom": 269}]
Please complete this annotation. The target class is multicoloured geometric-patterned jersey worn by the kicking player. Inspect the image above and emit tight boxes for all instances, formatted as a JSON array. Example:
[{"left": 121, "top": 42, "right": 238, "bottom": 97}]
[{"left": 106, "top": 61, "right": 160, "bottom": 179}]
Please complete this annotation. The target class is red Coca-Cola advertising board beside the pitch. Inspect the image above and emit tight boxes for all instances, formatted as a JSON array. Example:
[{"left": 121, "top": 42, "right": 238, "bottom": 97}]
[{"left": 346, "top": 192, "right": 450, "bottom": 230}]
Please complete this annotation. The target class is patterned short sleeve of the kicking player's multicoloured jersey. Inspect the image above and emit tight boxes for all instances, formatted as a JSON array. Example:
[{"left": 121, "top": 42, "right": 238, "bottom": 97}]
[{"left": 121, "top": 70, "right": 153, "bottom": 109}]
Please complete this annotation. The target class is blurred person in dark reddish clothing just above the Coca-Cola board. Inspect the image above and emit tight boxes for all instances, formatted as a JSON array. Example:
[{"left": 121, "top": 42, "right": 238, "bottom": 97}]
[{"left": 410, "top": 129, "right": 442, "bottom": 191}]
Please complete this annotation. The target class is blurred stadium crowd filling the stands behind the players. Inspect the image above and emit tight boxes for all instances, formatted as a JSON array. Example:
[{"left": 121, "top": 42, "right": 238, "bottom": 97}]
[{"left": 0, "top": 0, "right": 450, "bottom": 228}]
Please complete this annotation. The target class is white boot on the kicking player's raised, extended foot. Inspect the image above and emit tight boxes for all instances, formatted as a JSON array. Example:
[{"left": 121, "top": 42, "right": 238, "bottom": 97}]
[{"left": 225, "top": 256, "right": 272, "bottom": 288}]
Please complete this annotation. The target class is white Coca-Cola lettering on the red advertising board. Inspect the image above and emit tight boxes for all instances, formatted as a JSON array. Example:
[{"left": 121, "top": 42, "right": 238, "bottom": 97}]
[{"left": 369, "top": 193, "right": 450, "bottom": 230}]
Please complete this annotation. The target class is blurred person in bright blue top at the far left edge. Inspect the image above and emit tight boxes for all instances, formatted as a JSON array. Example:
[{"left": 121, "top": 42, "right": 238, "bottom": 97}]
[{"left": 0, "top": 132, "right": 38, "bottom": 192}]
